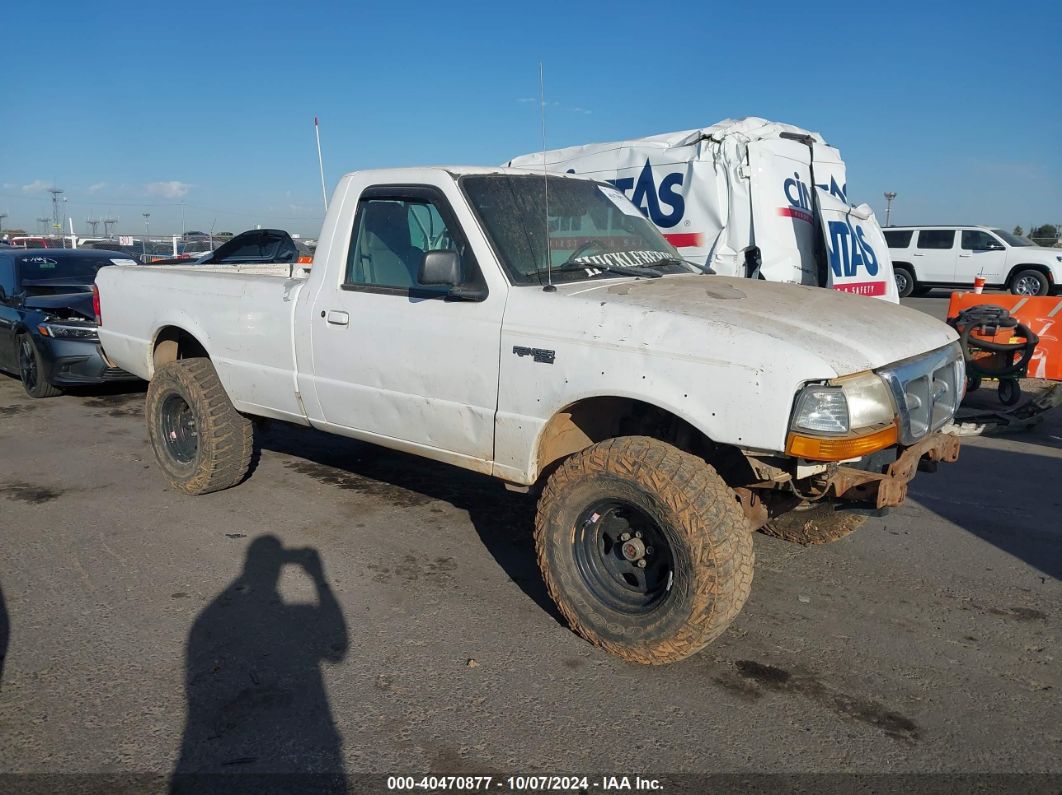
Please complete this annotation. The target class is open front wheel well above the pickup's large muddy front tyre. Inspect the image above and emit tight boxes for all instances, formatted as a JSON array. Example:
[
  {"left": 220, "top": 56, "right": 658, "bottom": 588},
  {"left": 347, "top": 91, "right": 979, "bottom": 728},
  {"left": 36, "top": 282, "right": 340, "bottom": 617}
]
[{"left": 536, "top": 397, "right": 752, "bottom": 485}]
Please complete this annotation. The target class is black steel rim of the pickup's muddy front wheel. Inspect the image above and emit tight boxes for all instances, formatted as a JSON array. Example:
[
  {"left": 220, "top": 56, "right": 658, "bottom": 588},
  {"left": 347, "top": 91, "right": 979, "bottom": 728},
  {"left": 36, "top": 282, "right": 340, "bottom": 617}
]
[{"left": 575, "top": 500, "right": 674, "bottom": 615}]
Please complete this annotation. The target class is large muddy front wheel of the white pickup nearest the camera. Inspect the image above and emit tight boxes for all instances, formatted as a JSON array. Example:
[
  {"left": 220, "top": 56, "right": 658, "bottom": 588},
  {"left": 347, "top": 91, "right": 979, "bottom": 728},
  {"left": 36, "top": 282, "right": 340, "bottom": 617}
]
[{"left": 535, "top": 436, "right": 754, "bottom": 664}]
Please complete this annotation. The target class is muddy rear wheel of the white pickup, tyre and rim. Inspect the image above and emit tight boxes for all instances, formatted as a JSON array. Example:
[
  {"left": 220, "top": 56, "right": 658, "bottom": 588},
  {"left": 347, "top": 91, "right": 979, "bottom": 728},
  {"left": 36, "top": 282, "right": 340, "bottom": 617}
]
[{"left": 145, "top": 359, "right": 254, "bottom": 495}]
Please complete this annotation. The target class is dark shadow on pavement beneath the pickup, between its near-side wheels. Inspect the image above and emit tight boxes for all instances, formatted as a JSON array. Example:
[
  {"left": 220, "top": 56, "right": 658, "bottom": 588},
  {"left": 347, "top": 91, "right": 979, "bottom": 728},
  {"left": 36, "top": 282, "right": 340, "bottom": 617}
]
[{"left": 259, "top": 422, "right": 567, "bottom": 626}]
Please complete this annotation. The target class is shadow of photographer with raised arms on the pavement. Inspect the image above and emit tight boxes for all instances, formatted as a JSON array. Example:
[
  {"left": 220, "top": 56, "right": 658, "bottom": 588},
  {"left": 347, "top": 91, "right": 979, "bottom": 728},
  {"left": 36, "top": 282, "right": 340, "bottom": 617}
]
[{"left": 170, "top": 535, "right": 347, "bottom": 793}]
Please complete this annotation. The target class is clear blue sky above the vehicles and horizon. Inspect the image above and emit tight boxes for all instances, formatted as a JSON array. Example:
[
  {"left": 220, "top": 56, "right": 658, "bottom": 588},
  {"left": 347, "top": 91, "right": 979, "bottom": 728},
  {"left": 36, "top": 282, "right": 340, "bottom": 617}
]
[{"left": 0, "top": 0, "right": 1062, "bottom": 236}]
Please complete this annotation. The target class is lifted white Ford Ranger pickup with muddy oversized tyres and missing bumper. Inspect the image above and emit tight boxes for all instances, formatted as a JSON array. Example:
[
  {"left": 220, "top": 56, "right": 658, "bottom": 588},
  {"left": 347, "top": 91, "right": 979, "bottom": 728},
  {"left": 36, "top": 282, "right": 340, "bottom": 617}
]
[{"left": 97, "top": 168, "right": 963, "bottom": 663}]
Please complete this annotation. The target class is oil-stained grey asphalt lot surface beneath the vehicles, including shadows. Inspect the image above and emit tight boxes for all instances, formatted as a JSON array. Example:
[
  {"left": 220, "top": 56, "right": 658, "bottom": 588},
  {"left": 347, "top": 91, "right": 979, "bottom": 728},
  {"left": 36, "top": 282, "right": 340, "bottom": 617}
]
[{"left": 0, "top": 297, "right": 1062, "bottom": 789}]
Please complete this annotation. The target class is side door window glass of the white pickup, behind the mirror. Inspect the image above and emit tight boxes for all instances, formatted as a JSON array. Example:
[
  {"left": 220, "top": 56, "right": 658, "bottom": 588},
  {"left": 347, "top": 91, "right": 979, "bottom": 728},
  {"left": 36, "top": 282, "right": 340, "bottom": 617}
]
[{"left": 345, "top": 198, "right": 458, "bottom": 291}]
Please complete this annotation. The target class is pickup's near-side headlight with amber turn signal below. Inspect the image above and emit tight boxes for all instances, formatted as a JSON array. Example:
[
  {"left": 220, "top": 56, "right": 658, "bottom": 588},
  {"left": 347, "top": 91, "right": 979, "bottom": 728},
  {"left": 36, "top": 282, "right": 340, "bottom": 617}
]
[{"left": 786, "top": 373, "right": 897, "bottom": 461}]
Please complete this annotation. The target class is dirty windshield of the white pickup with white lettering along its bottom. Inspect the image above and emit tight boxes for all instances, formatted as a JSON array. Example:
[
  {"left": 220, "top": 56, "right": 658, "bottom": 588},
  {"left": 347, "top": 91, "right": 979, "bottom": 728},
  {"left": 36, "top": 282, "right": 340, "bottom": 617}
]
[{"left": 461, "top": 174, "right": 699, "bottom": 284}]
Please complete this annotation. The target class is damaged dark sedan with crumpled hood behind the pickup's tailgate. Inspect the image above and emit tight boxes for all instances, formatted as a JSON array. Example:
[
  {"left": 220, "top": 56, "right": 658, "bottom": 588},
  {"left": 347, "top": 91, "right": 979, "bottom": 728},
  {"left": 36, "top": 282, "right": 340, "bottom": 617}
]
[{"left": 0, "top": 248, "right": 136, "bottom": 398}]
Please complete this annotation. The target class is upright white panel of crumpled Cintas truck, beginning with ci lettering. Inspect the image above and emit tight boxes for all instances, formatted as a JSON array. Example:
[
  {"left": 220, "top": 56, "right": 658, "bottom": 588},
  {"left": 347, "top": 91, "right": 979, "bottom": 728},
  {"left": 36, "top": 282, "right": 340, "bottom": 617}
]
[{"left": 749, "top": 138, "right": 819, "bottom": 284}]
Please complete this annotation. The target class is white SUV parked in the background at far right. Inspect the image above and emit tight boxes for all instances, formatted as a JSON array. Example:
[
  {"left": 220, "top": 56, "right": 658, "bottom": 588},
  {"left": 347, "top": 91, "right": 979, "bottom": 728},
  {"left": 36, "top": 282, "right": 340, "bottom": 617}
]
[{"left": 885, "top": 226, "right": 1062, "bottom": 297}]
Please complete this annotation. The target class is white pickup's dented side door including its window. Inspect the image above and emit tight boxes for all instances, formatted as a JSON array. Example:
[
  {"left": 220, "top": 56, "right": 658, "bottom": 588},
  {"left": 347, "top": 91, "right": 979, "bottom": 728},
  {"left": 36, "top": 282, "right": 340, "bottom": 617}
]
[{"left": 310, "top": 186, "right": 504, "bottom": 470}]
